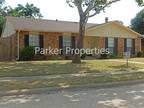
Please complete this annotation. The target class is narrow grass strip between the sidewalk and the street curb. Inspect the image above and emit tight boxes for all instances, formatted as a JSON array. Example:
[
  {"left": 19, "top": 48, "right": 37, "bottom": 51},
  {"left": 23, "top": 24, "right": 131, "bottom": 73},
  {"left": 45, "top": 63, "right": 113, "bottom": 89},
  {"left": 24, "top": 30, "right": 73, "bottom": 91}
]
[{"left": 0, "top": 73, "right": 144, "bottom": 91}]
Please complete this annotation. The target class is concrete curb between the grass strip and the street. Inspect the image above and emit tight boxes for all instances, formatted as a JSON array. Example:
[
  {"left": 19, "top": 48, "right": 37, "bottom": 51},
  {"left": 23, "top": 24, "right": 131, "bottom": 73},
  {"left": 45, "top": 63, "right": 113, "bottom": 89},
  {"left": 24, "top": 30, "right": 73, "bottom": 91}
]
[{"left": 0, "top": 80, "right": 144, "bottom": 96}]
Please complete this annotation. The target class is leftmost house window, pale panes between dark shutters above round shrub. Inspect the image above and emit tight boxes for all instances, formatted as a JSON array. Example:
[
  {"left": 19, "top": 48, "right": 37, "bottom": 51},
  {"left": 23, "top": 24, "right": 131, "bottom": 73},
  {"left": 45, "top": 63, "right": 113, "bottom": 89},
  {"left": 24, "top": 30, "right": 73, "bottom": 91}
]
[{"left": 29, "top": 34, "right": 40, "bottom": 47}]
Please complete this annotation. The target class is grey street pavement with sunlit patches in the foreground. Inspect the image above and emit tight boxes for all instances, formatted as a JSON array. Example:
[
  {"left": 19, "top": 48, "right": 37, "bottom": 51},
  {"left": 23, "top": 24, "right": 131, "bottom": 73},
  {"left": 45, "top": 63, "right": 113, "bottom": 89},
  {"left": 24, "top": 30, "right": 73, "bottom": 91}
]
[{"left": 0, "top": 84, "right": 144, "bottom": 108}]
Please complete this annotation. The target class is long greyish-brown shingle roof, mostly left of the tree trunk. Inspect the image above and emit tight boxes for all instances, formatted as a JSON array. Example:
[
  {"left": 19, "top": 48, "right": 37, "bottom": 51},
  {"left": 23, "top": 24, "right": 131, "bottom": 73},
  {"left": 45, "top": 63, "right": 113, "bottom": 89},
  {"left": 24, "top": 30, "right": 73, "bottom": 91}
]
[{"left": 7, "top": 17, "right": 97, "bottom": 32}]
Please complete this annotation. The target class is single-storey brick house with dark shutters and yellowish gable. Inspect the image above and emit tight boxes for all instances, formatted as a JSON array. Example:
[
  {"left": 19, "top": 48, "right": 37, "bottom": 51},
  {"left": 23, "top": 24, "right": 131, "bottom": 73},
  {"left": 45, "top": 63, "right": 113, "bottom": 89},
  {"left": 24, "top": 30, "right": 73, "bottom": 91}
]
[{"left": 0, "top": 17, "right": 141, "bottom": 59}]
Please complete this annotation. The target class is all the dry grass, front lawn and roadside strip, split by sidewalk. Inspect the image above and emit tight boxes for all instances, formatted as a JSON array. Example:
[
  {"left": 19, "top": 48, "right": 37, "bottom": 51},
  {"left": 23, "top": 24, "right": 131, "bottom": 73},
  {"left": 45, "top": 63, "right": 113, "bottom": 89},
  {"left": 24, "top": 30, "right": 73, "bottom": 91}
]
[{"left": 0, "top": 59, "right": 144, "bottom": 91}]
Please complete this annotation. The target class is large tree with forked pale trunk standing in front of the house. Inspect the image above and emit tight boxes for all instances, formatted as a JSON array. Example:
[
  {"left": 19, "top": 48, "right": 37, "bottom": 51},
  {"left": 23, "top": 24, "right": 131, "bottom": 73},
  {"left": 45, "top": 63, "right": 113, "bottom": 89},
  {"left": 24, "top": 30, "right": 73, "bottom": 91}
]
[{"left": 66, "top": 0, "right": 120, "bottom": 63}]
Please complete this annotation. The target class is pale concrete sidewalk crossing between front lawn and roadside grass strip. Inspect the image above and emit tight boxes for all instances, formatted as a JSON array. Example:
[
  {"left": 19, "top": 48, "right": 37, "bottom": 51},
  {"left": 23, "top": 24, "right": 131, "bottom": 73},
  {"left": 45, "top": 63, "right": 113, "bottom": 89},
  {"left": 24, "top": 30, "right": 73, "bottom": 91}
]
[{"left": 0, "top": 69, "right": 144, "bottom": 82}]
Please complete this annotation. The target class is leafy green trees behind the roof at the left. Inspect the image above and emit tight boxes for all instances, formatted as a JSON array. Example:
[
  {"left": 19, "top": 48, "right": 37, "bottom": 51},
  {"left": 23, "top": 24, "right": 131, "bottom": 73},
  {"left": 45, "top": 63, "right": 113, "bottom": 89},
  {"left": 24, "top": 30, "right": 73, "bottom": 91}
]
[{"left": 0, "top": 0, "right": 42, "bottom": 36}]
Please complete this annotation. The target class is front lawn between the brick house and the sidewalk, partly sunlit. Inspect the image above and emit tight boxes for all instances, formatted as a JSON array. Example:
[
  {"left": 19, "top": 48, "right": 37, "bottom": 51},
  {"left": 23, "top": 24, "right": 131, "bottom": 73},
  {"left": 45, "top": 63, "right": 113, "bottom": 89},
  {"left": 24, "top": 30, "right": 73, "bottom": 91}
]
[{"left": 0, "top": 60, "right": 144, "bottom": 77}]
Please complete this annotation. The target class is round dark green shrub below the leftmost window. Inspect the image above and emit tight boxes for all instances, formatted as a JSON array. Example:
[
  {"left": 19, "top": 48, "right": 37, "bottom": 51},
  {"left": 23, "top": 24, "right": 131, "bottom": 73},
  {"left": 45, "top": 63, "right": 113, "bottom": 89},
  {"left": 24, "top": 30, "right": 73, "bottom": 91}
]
[{"left": 20, "top": 46, "right": 35, "bottom": 61}]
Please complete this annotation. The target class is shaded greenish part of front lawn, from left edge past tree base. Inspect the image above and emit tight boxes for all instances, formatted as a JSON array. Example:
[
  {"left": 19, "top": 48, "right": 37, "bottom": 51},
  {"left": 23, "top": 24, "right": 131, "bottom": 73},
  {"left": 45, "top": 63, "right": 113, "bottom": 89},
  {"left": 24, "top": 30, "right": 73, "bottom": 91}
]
[{"left": 0, "top": 61, "right": 99, "bottom": 76}]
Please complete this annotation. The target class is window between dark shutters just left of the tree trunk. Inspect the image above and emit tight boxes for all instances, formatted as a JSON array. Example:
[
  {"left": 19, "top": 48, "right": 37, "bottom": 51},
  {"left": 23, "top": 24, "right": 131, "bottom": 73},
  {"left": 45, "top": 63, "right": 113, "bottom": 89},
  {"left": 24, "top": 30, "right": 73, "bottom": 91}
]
[{"left": 63, "top": 36, "right": 72, "bottom": 53}]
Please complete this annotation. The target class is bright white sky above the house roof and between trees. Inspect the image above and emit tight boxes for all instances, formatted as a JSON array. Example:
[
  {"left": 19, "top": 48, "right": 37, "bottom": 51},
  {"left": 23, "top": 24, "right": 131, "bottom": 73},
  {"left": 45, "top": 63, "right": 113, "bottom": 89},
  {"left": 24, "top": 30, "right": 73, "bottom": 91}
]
[{"left": 6, "top": 0, "right": 142, "bottom": 26}]
